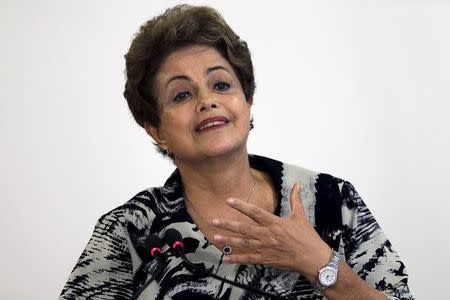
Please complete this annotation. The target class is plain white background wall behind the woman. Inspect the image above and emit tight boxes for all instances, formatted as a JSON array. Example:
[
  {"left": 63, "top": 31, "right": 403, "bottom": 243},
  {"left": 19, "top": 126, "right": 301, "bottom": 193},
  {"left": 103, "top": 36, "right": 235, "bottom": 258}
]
[{"left": 0, "top": 0, "right": 450, "bottom": 299}]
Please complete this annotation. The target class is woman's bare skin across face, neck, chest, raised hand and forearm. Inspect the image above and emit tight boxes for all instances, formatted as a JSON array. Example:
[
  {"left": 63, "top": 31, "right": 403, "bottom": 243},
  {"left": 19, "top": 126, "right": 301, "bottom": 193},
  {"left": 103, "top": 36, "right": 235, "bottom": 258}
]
[{"left": 145, "top": 45, "right": 386, "bottom": 299}]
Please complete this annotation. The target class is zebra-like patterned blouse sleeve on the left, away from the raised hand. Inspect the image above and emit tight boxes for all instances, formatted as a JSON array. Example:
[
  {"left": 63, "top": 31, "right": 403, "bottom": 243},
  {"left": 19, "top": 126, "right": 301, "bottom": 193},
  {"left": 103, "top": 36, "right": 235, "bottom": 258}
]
[{"left": 59, "top": 210, "right": 133, "bottom": 299}]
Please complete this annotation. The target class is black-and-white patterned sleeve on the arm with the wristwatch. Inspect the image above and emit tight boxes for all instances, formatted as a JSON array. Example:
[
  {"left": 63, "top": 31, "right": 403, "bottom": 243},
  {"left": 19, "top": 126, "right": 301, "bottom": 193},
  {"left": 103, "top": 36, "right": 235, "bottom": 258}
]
[{"left": 342, "top": 182, "right": 414, "bottom": 300}]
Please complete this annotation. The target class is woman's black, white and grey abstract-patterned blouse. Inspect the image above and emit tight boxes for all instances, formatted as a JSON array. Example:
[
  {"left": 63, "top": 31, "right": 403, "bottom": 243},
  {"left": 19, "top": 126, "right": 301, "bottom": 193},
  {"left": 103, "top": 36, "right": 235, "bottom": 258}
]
[{"left": 60, "top": 155, "right": 413, "bottom": 299}]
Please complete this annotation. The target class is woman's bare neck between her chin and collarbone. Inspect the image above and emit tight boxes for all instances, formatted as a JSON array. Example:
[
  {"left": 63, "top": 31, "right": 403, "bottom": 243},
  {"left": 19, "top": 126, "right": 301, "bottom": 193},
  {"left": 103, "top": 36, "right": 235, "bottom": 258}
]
[{"left": 177, "top": 151, "right": 254, "bottom": 204}]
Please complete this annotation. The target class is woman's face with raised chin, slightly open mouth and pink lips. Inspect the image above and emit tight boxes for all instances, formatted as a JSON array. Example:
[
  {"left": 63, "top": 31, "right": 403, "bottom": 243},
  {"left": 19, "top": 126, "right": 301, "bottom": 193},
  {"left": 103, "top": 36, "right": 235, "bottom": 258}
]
[{"left": 146, "top": 45, "right": 251, "bottom": 163}]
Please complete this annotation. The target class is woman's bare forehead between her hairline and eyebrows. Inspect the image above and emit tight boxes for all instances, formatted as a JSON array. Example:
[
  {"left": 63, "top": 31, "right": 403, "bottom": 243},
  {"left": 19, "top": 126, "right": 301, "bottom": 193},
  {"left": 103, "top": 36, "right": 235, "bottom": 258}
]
[{"left": 157, "top": 45, "right": 231, "bottom": 80}]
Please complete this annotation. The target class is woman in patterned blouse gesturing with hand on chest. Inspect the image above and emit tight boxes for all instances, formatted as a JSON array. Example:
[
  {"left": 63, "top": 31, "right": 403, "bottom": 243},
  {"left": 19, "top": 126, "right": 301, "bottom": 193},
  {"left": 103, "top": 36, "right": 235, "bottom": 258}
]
[{"left": 61, "top": 5, "right": 412, "bottom": 299}]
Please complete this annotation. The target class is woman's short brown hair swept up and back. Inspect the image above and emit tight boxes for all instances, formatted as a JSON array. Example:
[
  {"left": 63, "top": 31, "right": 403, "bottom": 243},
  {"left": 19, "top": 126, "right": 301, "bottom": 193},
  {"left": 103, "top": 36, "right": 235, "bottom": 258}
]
[{"left": 124, "top": 4, "right": 255, "bottom": 127}]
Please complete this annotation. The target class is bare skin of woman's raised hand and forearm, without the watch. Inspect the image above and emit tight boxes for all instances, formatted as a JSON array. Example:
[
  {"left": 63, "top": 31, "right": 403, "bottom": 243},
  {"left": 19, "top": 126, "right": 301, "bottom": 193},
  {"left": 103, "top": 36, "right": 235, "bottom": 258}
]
[{"left": 212, "top": 184, "right": 387, "bottom": 299}]
